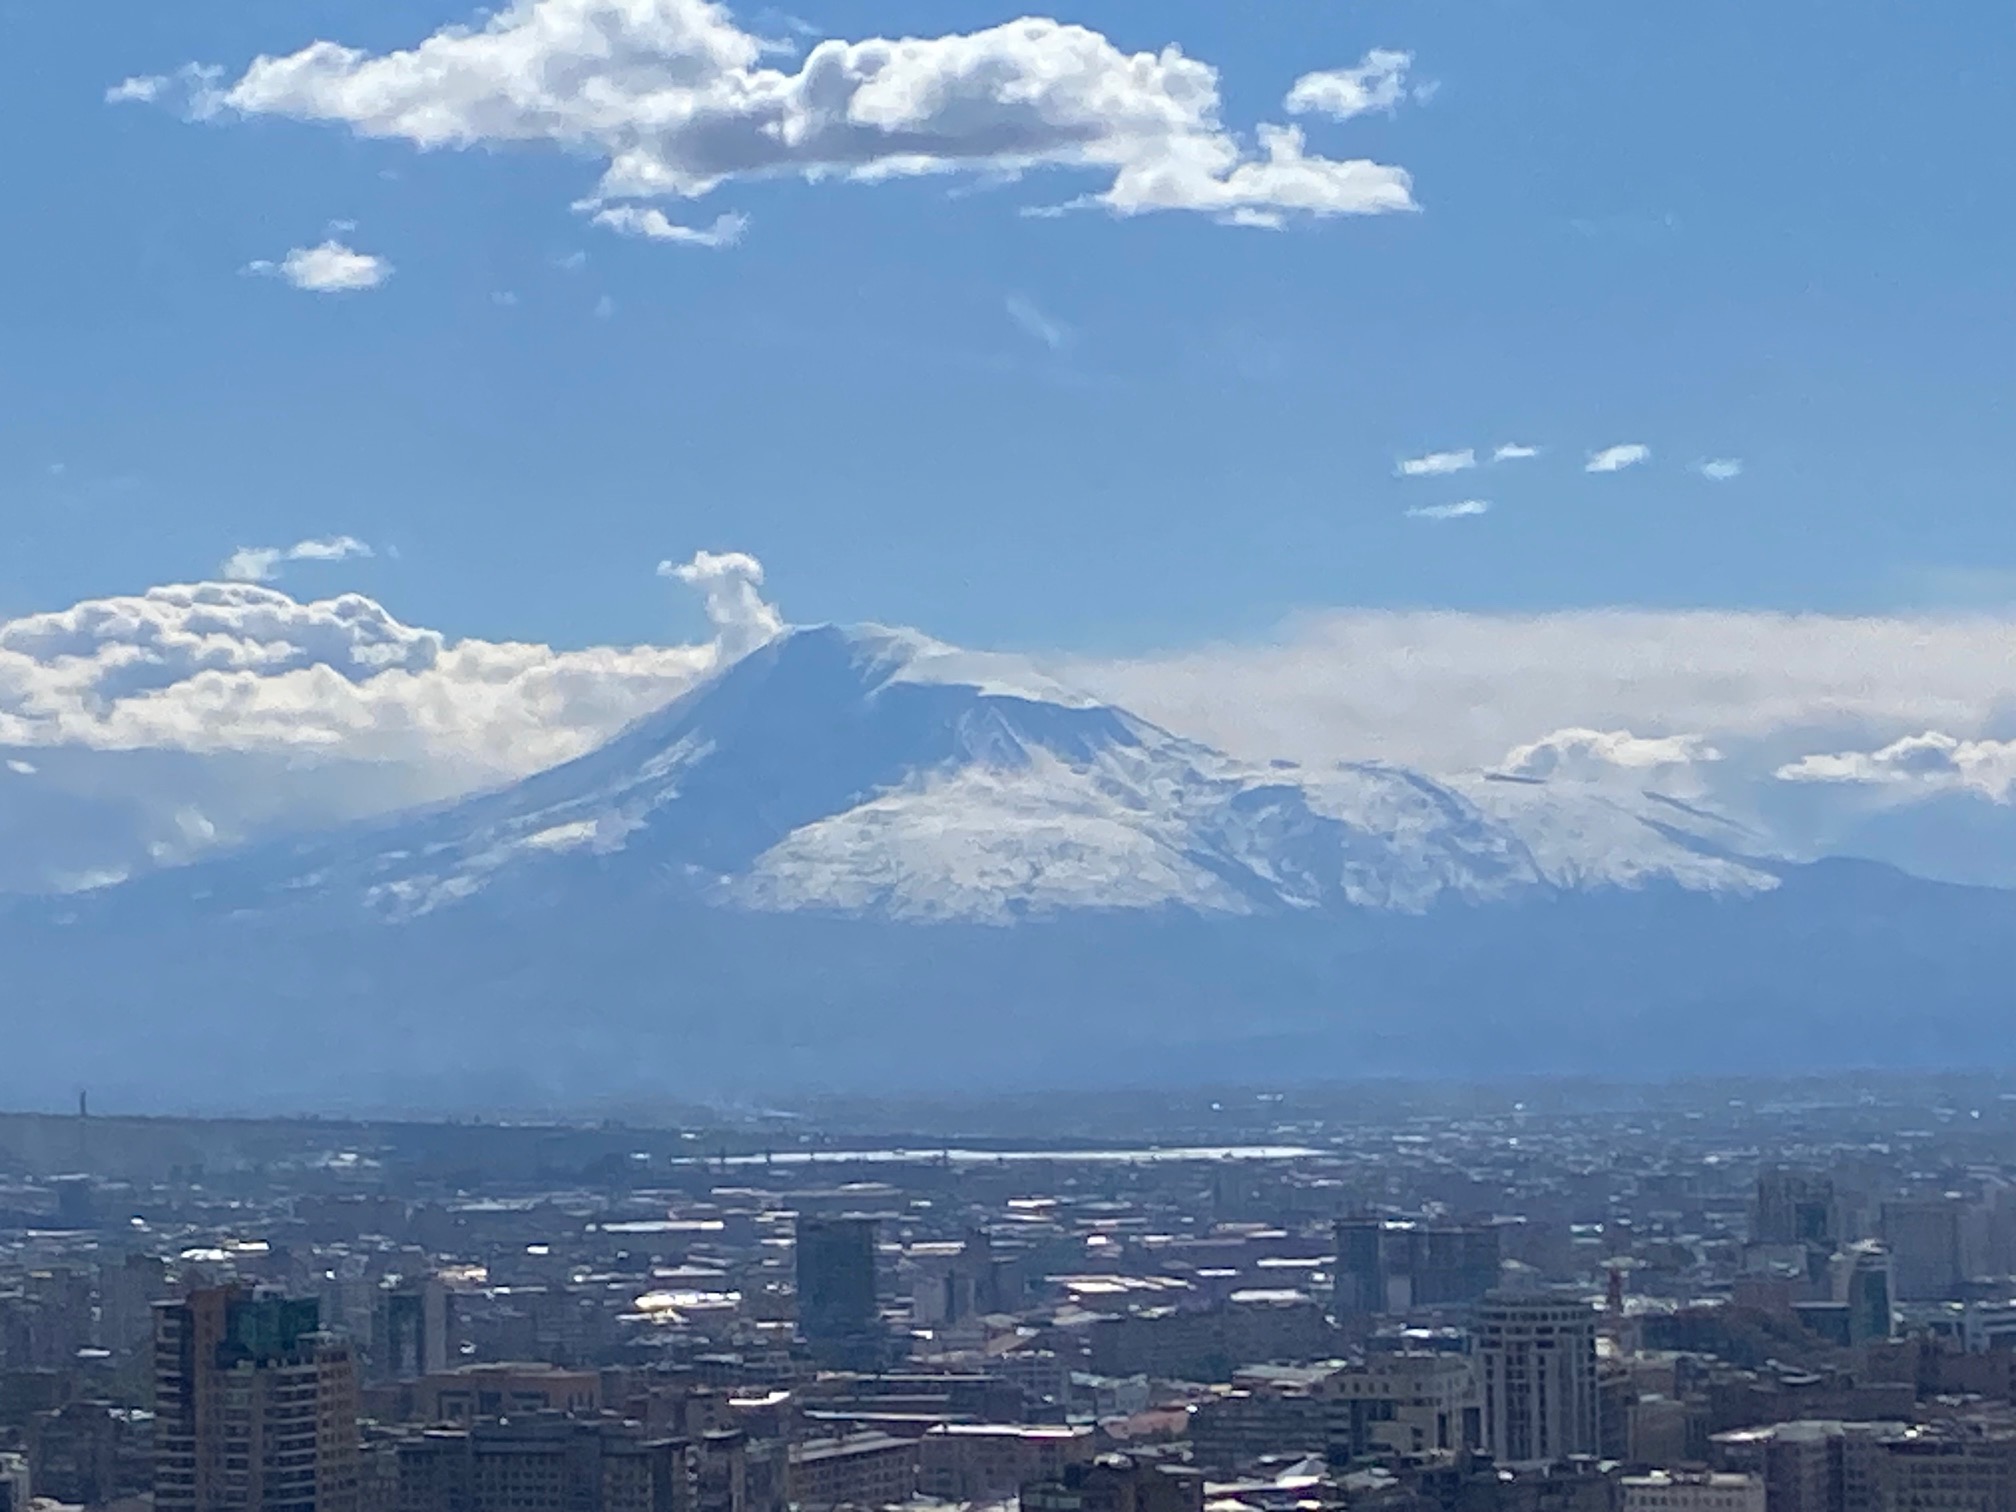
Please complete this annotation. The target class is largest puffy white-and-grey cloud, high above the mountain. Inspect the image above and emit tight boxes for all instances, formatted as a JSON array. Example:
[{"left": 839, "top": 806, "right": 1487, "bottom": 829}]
[{"left": 126, "top": 0, "right": 1415, "bottom": 226}]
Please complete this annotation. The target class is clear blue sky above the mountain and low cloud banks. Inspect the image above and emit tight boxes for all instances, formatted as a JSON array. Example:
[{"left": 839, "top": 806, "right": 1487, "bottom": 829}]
[{"left": 0, "top": 0, "right": 2016, "bottom": 651}]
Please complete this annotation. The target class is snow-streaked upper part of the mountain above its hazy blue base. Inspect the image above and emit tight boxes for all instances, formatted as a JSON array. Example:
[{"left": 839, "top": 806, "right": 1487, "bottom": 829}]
[{"left": 165, "top": 627, "right": 1776, "bottom": 923}]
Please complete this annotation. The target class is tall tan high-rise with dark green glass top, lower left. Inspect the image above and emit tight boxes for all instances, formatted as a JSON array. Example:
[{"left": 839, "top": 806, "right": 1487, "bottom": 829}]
[{"left": 153, "top": 1286, "right": 357, "bottom": 1512}]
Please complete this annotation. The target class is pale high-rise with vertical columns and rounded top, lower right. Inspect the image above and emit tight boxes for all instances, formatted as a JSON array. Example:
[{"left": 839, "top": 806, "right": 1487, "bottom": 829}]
[{"left": 1476, "top": 1292, "right": 1599, "bottom": 1466}]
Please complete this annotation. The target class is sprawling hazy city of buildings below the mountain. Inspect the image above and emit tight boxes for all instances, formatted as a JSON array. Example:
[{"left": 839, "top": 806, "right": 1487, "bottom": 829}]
[{"left": 0, "top": 1077, "right": 2016, "bottom": 1512}]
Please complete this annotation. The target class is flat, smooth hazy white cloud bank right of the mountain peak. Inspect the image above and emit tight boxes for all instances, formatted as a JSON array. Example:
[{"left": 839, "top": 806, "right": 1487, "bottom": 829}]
[{"left": 1056, "top": 609, "right": 2016, "bottom": 776}]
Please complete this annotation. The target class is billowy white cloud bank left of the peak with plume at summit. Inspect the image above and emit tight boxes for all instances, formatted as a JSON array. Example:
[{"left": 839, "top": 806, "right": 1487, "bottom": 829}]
[{"left": 0, "top": 542, "right": 782, "bottom": 782}]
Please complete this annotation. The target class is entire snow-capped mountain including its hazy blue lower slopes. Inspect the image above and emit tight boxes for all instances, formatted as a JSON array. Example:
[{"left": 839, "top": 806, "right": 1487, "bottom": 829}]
[{"left": 0, "top": 627, "right": 2016, "bottom": 1109}]
